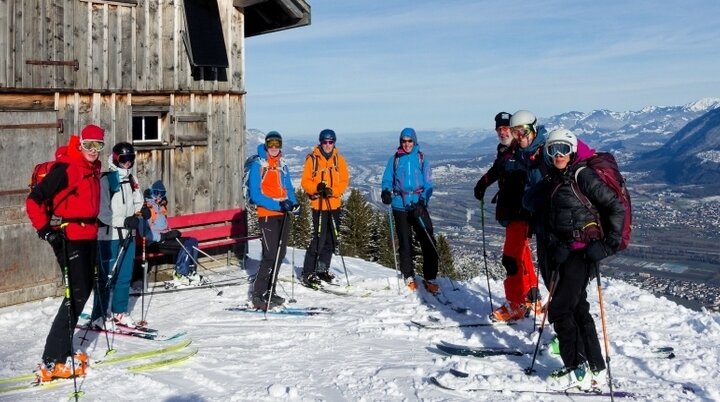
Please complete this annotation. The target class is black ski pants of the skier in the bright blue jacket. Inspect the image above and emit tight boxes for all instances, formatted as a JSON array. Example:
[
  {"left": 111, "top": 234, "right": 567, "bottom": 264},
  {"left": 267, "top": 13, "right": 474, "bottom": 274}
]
[{"left": 393, "top": 206, "right": 438, "bottom": 280}]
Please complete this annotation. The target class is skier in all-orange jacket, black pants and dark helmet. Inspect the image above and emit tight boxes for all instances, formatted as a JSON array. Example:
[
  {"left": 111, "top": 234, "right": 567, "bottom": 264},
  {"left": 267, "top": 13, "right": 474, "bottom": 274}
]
[{"left": 300, "top": 129, "right": 350, "bottom": 287}]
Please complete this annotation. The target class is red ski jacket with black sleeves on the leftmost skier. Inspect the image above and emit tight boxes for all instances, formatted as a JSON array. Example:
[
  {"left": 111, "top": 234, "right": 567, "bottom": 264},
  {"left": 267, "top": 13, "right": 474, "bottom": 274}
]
[{"left": 25, "top": 135, "right": 101, "bottom": 240}]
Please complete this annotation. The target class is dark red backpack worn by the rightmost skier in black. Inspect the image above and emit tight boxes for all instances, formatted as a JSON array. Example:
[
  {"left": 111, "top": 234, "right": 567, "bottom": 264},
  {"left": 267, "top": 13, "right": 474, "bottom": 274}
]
[{"left": 572, "top": 152, "right": 632, "bottom": 251}]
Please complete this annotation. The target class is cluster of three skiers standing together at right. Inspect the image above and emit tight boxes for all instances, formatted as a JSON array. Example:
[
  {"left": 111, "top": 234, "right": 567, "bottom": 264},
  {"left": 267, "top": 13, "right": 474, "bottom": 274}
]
[{"left": 475, "top": 110, "right": 625, "bottom": 390}]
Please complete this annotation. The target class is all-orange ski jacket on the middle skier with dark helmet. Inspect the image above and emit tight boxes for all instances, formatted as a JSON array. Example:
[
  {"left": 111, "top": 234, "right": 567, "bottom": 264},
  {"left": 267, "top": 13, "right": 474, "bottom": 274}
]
[{"left": 300, "top": 145, "right": 350, "bottom": 211}]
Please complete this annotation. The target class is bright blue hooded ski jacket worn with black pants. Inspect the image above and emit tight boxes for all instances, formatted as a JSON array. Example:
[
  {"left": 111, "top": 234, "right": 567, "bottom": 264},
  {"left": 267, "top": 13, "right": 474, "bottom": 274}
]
[{"left": 382, "top": 140, "right": 433, "bottom": 211}]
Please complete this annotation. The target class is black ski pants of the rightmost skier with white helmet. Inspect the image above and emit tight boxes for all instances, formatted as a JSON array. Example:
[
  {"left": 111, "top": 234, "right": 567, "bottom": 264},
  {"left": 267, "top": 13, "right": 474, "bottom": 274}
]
[{"left": 548, "top": 249, "right": 605, "bottom": 371}]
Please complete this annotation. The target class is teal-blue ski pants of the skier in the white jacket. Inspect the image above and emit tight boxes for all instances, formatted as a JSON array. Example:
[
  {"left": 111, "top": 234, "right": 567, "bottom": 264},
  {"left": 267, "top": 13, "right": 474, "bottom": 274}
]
[{"left": 90, "top": 236, "right": 135, "bottom": 321}]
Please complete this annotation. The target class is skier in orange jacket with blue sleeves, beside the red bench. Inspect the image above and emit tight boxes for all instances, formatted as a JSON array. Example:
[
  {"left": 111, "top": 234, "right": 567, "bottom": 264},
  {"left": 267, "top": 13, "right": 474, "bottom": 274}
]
[{"left": 248, "top": 131, "right": 300, "bottom": 310}]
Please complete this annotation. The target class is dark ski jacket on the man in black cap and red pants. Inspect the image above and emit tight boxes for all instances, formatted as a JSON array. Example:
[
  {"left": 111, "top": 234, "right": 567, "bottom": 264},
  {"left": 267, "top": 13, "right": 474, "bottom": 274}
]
[{"left": 480, "top": 143, "right": 530, "bottom": 226}]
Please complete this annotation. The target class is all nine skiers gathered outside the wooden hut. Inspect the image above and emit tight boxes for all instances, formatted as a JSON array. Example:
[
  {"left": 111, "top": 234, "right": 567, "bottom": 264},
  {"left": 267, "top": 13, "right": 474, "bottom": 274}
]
[{"left": 26, "top": 116, "right": 623, "bottom": 389}]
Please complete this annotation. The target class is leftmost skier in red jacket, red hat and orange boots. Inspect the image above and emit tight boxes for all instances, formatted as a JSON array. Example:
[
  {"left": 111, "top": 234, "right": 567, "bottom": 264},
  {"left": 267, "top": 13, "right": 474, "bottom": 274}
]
[{"left": 25, "top": 124, "right": 105, "bottom": 382}]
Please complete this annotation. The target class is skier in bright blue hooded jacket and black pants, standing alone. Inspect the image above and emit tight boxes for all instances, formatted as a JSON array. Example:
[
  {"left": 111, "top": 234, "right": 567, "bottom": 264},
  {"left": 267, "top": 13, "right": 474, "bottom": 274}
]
[{"left": 381, "top": 128, "right": 440, "bottom": 293}]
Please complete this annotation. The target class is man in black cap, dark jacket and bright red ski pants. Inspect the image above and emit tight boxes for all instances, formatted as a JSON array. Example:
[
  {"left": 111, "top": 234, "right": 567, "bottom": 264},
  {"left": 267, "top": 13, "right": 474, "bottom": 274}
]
[{"left": 475, "top": 112, "right": 542, "bottom": 321}]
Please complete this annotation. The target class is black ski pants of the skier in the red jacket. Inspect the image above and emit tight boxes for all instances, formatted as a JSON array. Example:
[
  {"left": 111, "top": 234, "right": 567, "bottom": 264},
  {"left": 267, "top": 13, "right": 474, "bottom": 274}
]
[{"left": 42, "top": 240, "right": 97, "bottom": 363}]
